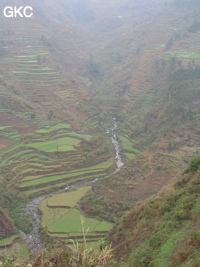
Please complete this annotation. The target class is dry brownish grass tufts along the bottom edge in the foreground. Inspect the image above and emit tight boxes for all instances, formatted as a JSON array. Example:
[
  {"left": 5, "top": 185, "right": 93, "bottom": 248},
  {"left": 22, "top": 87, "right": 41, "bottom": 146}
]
[{"left": 0, "top": 239, "right": 117, "bottom": 267}]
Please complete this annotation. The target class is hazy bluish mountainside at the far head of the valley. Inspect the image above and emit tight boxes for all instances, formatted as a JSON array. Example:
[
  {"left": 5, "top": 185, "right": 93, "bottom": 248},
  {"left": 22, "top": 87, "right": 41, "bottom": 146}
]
[{"left": 37, "top": 0, "right": 166, "bottom": 95}]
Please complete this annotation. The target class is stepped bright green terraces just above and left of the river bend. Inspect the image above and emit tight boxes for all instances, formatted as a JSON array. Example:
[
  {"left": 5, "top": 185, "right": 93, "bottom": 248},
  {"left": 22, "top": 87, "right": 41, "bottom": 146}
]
[{"left": 0, "top": 120, "right": 114, "bottom": 194}]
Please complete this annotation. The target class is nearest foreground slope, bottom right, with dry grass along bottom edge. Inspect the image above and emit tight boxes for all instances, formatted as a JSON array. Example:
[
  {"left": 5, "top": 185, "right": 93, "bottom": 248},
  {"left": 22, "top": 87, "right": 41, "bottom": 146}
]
[{"left": 1, "top": 156, "right": 200, "bottom": 267}]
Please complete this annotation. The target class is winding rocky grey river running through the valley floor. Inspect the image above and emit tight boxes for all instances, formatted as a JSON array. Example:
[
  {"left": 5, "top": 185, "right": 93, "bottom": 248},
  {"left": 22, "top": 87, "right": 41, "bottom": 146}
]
[{"left": 20, "top": 118, "right": 124, "bottom": 255}]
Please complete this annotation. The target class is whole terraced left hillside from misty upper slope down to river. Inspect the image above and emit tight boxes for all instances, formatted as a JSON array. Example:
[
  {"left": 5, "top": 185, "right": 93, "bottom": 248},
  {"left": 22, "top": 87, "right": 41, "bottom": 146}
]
[{"left": 0, "top": 14, "right": 111, "bottom": 207}]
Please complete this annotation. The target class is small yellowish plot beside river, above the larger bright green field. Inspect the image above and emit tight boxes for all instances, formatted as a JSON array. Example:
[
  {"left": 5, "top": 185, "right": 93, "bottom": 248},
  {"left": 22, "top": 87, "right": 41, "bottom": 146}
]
[{"left": 48, "top": 186, "right": 91, "bottom": 208}]
